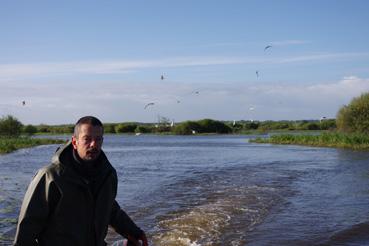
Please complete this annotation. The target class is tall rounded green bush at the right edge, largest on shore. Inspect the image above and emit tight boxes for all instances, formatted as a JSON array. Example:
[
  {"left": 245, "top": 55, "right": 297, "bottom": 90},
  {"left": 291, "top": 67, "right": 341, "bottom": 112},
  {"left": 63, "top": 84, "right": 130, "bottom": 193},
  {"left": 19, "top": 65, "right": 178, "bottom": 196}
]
[{"left": 336, "top": 93, "right": 369, "bottom": 135}]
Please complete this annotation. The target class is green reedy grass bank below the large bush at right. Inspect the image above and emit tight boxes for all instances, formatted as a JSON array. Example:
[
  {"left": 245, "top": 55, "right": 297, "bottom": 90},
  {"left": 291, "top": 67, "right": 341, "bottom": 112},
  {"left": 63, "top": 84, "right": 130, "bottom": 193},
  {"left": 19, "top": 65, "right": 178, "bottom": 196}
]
[{"left": 250, "top": 133, "right": 369, "bottom": 150}]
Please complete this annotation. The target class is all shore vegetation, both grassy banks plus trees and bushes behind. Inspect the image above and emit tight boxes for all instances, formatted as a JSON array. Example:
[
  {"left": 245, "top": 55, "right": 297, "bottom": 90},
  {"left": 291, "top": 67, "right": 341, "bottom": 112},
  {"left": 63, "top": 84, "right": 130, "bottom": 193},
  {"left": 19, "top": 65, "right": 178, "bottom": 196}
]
[{"left": 0, "top": 93, "right": 369, "bottom": 153}]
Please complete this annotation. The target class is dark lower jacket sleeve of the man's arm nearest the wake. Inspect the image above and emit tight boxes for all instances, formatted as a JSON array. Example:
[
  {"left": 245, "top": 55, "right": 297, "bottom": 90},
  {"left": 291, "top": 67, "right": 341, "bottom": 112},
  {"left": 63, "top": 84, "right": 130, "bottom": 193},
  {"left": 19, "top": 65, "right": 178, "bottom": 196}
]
[{"left": 110, "top": 201, "right": 143, "bottom": 239}]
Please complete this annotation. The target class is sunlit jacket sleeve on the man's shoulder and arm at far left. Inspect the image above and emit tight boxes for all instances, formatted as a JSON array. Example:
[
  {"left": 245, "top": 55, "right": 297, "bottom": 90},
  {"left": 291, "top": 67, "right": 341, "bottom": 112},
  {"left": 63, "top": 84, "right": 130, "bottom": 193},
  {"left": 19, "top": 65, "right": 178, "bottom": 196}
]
[{"left": 14, "top": 170, "right": 56, "bottom": 246}]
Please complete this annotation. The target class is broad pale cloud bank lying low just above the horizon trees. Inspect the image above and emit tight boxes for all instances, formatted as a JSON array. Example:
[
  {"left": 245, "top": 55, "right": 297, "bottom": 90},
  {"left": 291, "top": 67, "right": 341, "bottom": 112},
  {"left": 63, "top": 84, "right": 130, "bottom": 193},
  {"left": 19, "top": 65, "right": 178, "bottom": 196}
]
[{"left": 0, "top": 76, "right": 369, "bottom": 124}]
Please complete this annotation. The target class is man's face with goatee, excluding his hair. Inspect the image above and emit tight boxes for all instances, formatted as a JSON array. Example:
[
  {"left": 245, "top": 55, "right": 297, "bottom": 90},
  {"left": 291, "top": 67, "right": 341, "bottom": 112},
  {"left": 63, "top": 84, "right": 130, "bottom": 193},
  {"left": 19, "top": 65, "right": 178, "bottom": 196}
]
[{"left": 72, "top": 124, "right": 103, "bottom": 161}]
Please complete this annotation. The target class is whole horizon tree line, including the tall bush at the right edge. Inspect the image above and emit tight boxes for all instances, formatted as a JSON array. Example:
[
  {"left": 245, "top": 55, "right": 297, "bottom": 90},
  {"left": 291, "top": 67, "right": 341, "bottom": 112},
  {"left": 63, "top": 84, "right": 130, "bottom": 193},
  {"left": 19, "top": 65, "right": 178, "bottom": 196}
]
[{"left": 0, "top": 93, "right": 369, "bottom": 137}]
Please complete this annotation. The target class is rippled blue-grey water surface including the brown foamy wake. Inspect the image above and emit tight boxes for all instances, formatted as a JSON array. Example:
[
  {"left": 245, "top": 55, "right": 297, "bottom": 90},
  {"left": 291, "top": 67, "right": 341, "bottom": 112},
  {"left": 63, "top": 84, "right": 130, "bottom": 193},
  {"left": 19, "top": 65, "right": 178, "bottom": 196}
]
[{"left": 0, "top": 135, "right": 369, "bottom": 246}]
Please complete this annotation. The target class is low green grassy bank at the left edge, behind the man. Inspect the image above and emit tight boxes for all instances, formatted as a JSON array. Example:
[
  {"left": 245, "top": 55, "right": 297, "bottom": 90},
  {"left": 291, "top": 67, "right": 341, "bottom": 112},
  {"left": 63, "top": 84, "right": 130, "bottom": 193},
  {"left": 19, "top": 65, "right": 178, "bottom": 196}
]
[{"left": 0, "top": 137, "right": 65, "bottom": 154}]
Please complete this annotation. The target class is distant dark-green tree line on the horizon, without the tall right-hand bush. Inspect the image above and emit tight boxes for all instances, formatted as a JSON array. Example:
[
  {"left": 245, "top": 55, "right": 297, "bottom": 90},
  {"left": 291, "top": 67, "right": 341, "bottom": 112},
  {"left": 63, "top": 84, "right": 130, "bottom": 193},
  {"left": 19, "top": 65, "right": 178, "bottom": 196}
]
[{"left": 0, "top": 115, "right": 336, "bottom": 137}]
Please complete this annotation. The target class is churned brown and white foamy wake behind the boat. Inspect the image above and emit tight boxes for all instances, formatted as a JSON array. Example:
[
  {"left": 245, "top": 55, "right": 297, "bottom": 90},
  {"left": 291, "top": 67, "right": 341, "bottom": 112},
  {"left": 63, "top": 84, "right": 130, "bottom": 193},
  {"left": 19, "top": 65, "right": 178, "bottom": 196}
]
[{"left": 153, "top": 186, "right": 273, "bottom": 246}]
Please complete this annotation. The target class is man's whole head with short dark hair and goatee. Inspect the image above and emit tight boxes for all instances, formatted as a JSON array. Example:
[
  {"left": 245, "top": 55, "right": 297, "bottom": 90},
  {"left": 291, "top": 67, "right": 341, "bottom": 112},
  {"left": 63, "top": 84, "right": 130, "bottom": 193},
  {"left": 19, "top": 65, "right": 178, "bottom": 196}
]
[{"left": 72, "top": 116, "right": 104, "bottom": 162}]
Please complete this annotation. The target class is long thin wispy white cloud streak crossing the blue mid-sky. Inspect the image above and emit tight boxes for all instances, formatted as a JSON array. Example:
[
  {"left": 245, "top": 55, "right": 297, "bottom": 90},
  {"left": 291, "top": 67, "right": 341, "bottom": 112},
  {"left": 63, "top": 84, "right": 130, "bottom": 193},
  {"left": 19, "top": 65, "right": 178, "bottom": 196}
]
[{"left": 0, "top": 53, "right": 369, "bottom": 81}]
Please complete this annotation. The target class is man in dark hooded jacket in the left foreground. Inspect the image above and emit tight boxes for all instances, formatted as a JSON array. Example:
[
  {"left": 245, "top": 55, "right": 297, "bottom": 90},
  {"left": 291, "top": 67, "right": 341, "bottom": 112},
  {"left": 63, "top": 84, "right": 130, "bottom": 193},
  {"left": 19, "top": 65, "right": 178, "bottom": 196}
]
[{"left": 14, "top": 116, "right": 148, "bottom": 246}]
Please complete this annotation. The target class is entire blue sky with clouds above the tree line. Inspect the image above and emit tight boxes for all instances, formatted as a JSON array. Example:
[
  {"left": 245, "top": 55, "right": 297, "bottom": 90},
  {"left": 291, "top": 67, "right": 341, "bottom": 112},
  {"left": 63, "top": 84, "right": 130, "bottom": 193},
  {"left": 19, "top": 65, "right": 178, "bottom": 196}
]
[{"left": 0, "top": 0, "right": 369, "bottom": 125}]
